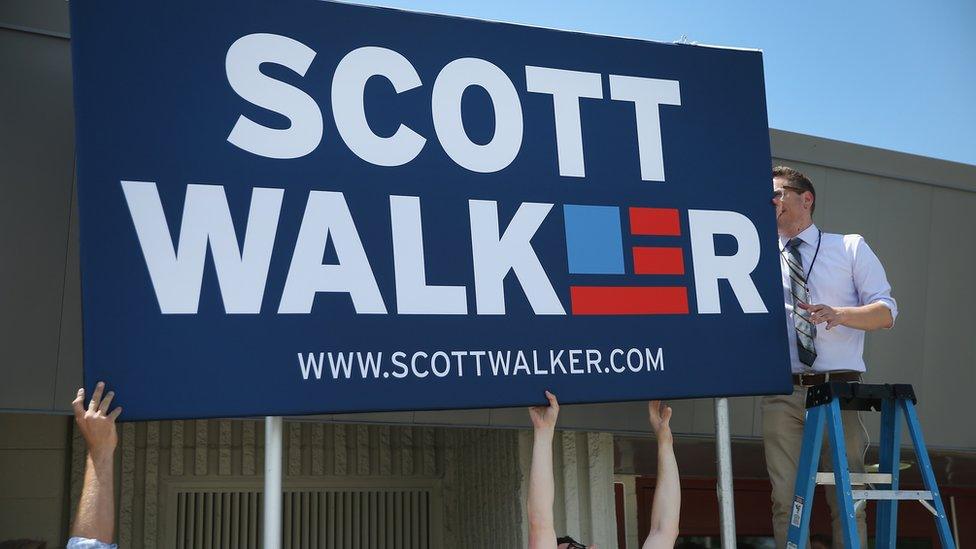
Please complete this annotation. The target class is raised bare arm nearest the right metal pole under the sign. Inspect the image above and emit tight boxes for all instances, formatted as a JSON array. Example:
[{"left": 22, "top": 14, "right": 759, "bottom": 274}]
[{"left": 643, "top": 400, "right": 681, "bottom": 549}]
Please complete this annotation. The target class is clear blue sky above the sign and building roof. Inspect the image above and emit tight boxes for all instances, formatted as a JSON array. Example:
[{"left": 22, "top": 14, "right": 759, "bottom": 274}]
[{"left": 356, "top": 0, "right": 976, "bottom": 165}]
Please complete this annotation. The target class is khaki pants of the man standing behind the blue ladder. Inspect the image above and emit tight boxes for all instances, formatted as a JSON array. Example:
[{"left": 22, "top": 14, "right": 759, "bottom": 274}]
[{"left": 762, "top": 385, "right": 867, "bottom": 548}]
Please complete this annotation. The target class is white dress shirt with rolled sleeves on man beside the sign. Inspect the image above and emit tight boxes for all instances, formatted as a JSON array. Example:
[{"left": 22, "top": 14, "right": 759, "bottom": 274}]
[{"left": 779, "top": 225, "right": 898, "bottom": 374}]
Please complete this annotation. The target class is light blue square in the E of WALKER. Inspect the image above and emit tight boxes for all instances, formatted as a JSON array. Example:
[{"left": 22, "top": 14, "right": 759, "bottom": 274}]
[{"left": 563, "top": 204, "right": 624, "bottom": 274}]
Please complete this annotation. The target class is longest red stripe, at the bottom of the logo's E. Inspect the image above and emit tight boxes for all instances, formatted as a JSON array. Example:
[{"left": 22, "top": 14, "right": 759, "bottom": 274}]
[{"left": 569, "top": 286, "right": 688, "bottom": 315}]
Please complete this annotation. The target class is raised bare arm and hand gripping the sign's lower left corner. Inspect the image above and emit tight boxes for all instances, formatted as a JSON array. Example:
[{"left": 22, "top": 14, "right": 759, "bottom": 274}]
[{"left": 71, "top": 382, "right": 122, "bottom": 543}]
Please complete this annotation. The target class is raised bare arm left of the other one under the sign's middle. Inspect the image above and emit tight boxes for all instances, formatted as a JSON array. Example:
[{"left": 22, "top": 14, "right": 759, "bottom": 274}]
[{"left": 526, "top": 391, "right": 559, "bottom": 549}]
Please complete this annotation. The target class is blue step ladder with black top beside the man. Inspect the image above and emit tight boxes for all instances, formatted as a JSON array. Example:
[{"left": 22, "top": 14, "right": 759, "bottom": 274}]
[{"left": 786, "top": 381, "right": 956, "bottom": 549}]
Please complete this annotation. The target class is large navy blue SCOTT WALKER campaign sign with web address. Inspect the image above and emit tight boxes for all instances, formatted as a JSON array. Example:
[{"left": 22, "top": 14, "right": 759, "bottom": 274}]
[{"left": 71, "top": 0, "right": 790, "bottom": 419}]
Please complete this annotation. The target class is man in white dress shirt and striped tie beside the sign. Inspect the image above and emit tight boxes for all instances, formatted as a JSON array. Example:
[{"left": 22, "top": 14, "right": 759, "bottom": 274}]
[{"left": 762, "top": 166, "right": 898, "bottom": 547}]
